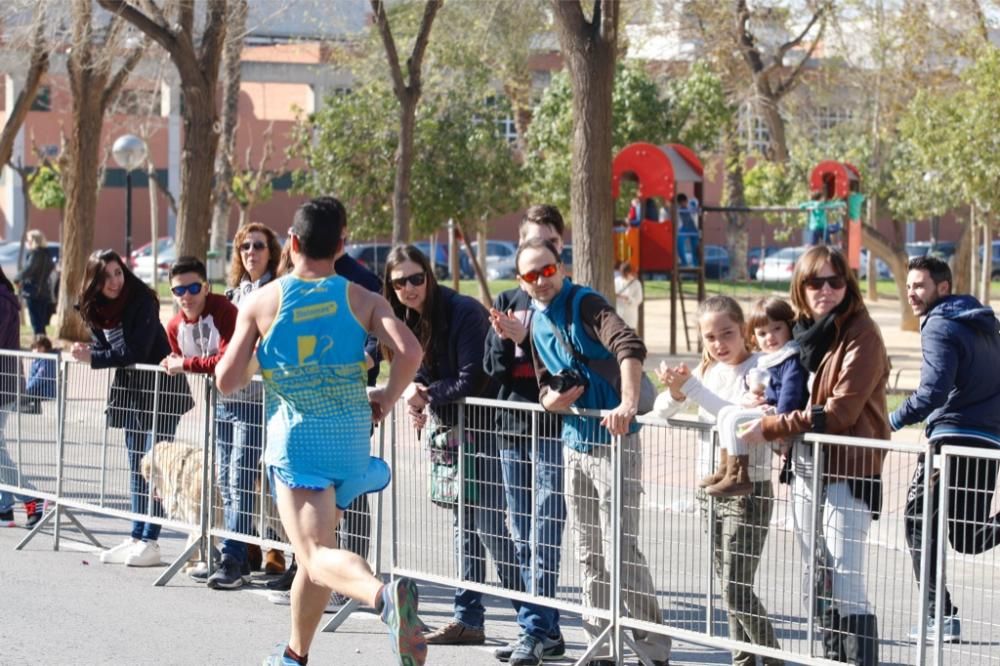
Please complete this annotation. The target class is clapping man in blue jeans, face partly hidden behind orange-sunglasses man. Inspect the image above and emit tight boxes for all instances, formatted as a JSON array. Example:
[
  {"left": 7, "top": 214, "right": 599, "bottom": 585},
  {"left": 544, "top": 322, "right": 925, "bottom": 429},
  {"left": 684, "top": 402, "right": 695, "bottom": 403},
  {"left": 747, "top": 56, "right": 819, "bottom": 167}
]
[{"left": 483, "top": 205, "right": 566, "bottom": 666}]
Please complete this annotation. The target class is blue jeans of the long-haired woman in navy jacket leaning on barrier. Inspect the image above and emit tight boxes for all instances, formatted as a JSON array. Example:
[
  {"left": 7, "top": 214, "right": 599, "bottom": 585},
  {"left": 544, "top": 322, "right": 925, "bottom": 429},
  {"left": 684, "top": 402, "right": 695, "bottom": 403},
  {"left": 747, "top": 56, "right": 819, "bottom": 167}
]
[{"left": 452, "top": 438, "right": 524, "bottom": 629}]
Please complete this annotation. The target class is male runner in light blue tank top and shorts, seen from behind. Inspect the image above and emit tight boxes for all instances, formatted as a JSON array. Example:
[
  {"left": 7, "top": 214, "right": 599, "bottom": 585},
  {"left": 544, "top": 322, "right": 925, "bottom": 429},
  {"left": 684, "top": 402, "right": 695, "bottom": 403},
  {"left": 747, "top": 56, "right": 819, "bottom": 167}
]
[{"left": 216, "top": 200, "right": 427, "bottom": 666}]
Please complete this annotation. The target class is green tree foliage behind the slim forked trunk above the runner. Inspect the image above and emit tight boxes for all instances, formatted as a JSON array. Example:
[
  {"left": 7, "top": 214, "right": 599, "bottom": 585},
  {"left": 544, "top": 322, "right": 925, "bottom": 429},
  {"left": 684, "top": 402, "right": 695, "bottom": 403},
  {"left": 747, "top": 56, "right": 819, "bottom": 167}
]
[{"left": 289, "top": 80, "right": 520, "bottom": 240}]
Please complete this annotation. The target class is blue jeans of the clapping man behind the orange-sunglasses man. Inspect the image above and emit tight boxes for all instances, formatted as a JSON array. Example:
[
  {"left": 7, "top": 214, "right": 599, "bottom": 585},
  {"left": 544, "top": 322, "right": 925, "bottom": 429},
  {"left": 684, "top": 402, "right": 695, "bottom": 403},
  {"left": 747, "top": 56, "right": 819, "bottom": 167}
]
[{"left": 500, "top": 437, "right": 566, "bottom": 639}]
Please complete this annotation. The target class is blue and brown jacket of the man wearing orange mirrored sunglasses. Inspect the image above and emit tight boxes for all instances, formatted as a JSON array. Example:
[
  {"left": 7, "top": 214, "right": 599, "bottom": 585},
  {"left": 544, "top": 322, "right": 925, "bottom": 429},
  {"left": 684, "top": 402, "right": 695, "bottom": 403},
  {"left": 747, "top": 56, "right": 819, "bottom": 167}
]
[{"left": 531, "top": 278, "right": 646, "bottom": 453}]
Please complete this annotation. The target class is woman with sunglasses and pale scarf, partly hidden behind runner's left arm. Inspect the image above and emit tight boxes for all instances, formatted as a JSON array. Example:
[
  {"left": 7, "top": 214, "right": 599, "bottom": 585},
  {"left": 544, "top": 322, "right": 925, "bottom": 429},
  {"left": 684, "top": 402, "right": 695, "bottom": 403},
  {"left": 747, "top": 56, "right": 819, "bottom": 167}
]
[{"left": 216, "top": 222, "right": 285, "bottom": 576}]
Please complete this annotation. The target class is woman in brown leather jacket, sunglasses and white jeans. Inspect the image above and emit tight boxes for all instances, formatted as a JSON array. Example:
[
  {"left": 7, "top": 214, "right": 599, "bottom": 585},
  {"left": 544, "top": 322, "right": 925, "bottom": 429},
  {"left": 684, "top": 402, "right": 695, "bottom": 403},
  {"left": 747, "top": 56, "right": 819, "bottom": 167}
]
[{"left": 743, "top": 245, "right": 889, "bottom": 665}]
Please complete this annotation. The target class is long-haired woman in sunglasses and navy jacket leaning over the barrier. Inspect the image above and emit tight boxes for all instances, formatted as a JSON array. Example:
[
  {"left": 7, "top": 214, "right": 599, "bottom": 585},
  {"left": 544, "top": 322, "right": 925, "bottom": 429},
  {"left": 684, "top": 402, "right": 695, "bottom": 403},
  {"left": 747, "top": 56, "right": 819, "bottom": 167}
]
[{"left": 385, "top": 245, "right": 523, "bottom": 645}]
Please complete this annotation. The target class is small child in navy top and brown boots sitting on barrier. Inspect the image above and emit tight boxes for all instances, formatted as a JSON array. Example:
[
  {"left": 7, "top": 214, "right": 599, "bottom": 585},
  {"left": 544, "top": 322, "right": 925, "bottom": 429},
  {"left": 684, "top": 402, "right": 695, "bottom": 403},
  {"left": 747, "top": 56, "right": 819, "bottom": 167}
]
[{"left": 698, "top": 298, "right": 809, "bottom": 497}]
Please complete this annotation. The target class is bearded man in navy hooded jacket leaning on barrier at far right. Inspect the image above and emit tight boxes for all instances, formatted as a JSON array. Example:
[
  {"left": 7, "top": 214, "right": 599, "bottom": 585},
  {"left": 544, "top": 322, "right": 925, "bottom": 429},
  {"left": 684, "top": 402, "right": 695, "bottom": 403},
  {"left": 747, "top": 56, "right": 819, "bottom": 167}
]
[{"left": 889, "top": 257, "right": 1000, "bottom": 642}]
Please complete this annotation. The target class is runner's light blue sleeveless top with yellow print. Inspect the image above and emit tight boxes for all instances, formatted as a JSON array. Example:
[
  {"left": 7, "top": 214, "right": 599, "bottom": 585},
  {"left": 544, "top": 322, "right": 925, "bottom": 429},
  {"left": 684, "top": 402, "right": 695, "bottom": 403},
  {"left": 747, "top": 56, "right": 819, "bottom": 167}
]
[{"left": 257, "top": 275, "right": 371, "bottom": 480}]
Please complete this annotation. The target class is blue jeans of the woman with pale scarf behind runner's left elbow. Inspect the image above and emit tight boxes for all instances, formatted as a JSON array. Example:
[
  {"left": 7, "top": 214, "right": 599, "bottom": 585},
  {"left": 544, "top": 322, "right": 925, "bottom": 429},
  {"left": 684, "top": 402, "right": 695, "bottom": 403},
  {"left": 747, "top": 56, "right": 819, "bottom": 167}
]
[{"left": 215, "top": 401, "right": 263, "bottom": 563}]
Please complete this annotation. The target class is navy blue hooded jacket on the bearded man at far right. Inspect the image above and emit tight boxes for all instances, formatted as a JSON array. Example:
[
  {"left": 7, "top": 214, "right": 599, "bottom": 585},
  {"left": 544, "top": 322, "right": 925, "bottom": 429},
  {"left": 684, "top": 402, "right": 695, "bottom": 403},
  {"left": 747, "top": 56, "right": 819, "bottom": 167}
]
[{"left": 889, "top": 296, "right": 1000, "bottom": 446}]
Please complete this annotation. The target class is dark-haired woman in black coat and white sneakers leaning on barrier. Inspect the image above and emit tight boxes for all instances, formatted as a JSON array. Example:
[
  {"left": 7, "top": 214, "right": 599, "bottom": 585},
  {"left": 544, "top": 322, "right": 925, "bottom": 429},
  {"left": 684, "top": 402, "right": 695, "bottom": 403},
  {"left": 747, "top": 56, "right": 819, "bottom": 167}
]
[{"left": 70, "top": 250, "right": 192, "bottom": 567}]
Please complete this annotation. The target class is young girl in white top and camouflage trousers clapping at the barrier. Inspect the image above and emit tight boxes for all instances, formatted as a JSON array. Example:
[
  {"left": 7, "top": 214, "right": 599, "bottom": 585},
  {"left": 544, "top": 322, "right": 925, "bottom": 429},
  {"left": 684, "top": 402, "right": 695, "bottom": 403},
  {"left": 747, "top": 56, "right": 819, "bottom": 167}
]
[{"left": 652, "top": 296, "right": 782, "bottom": 665}]
